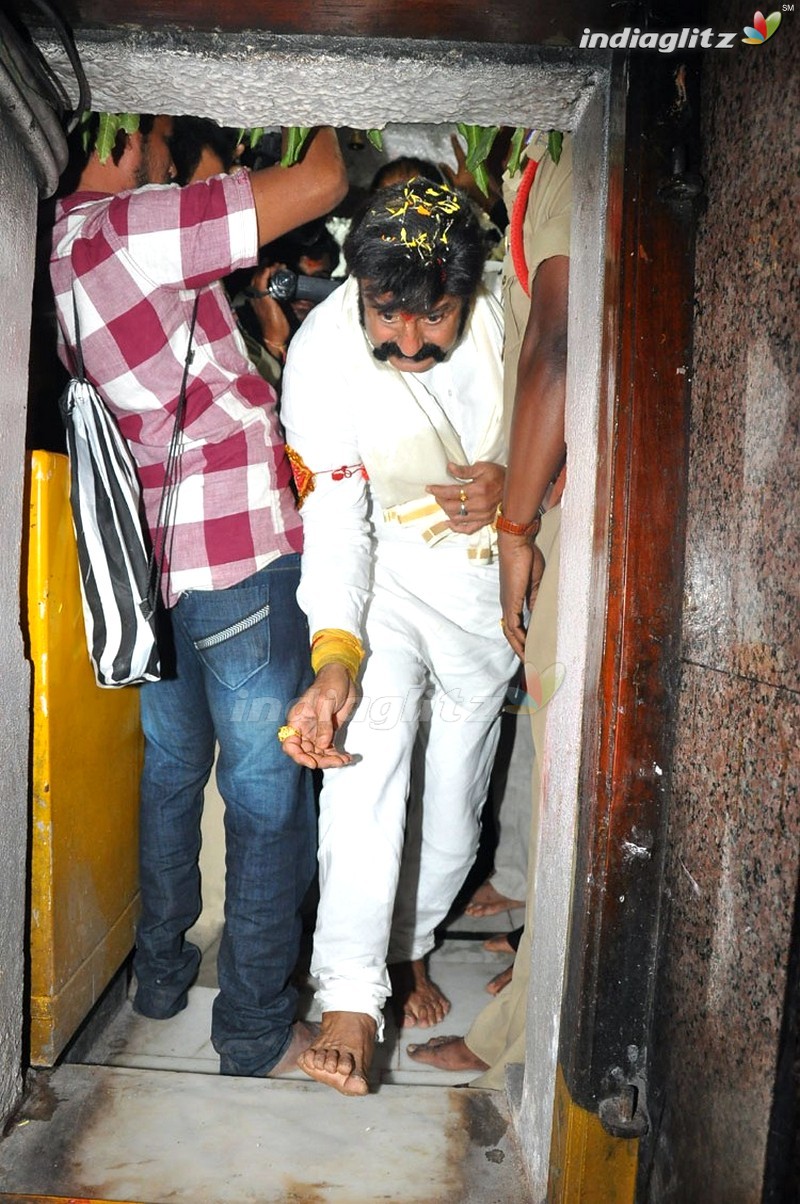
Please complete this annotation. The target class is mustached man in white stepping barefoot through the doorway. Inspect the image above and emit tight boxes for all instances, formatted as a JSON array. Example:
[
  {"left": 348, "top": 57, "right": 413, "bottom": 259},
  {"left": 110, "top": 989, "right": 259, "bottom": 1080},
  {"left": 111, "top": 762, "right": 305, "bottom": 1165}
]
[{"left": 281, "top": 181, "right": 513, "bottom": 1094}]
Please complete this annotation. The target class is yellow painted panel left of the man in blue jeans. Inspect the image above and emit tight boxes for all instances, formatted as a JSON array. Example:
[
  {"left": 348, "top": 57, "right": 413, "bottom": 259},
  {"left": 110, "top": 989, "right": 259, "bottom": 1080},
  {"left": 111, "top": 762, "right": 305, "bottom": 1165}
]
[{"left": 28, "top": 452, "right": 142, "bottom": 1066}]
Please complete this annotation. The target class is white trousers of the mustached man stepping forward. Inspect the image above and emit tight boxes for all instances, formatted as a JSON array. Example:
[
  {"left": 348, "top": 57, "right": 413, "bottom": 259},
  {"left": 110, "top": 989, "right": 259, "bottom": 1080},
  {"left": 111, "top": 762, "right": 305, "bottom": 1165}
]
[{"left": 311, "top": 545, "right": 514, "bottom": 1029}]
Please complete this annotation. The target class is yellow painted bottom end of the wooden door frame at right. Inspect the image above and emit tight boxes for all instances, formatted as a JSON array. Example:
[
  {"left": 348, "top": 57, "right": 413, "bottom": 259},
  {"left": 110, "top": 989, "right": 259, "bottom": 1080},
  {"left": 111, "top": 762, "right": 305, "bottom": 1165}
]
[{"left": 547, "top": 1066, "right": 639, "bottom": 1204}]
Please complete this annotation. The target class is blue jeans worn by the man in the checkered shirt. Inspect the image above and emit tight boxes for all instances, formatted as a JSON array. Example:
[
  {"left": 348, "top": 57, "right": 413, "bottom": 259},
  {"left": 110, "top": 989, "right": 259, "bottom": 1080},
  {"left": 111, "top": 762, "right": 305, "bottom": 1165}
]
[{"left": 134, "top": 555, "right": 316, "bottom": 1075}]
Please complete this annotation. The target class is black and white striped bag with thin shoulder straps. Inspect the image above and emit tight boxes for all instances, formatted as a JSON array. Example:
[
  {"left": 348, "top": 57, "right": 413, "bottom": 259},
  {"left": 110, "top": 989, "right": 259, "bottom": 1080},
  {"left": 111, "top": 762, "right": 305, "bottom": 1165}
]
[{"left": 59, "top": 299, "right": 198, "bottom": 686}]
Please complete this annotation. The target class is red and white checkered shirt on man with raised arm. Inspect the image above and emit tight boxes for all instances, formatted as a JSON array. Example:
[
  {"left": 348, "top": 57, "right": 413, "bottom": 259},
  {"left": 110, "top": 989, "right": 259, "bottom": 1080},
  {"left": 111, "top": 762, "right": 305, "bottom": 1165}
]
[{"left": 51, "top": 172, "right": 302, "bottom": 606}]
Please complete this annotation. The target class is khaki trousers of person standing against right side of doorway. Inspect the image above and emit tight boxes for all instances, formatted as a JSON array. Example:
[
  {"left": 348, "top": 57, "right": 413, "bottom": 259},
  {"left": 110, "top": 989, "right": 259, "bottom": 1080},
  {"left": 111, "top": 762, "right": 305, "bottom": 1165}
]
[{"left": 466, "top": 506, "right": 561, "bottom": 1088}]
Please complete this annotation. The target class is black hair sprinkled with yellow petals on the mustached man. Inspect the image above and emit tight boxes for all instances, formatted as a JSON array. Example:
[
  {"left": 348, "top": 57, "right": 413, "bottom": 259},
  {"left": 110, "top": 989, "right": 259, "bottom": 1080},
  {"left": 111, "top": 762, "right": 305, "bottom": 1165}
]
[{"left": 345, "top": 178, "right": 486, "bottom": 313}]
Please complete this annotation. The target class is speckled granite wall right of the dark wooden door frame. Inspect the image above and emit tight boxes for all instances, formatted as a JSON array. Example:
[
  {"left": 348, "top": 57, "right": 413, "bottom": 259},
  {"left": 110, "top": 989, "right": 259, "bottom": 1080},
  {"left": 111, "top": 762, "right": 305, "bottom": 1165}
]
[{"left": 646, "top": 2, "right": 800, "bottom": 1204}]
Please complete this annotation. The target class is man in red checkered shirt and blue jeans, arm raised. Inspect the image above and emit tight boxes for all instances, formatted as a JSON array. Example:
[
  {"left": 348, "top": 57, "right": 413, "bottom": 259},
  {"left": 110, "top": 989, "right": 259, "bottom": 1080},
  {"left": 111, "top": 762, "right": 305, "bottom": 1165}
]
[{"left": 51, "top": 116, "right": 347, "bottom": 1075}]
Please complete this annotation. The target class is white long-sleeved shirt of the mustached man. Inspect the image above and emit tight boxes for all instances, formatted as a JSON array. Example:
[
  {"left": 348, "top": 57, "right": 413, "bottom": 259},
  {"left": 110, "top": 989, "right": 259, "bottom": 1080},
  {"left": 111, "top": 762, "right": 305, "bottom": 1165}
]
[{"left": 281, "top": 281, "right": 505, "bottom": 636}]
